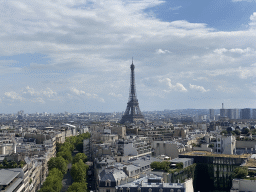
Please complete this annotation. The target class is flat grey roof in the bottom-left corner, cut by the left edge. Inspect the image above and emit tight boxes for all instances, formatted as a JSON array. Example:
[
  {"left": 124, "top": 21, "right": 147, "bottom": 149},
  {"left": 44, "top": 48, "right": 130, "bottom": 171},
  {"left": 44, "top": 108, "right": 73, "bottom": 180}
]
[{"left": 0, "top": 168, "right": 22, "bottom": 185}]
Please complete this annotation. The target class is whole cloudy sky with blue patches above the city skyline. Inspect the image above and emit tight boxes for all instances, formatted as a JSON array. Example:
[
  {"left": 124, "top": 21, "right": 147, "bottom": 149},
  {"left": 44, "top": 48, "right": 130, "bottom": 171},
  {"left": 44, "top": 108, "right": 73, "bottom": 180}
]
[{"left": 0, "top": 0, "right": 256, "bottom": 113}]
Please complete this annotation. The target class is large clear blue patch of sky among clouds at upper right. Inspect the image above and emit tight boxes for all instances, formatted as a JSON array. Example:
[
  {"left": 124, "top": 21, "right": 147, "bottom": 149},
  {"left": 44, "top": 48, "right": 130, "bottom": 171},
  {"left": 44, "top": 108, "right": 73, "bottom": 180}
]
[{"left": 147, "top": 0, "right": 256, "bottom": 31}]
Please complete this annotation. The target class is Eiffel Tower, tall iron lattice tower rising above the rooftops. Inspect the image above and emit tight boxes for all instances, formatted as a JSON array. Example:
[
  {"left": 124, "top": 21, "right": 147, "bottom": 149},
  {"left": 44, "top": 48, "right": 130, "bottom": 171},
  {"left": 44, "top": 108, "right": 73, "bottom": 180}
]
[{"left": 120, "top": 60, "right": 144, "bottom": 124}]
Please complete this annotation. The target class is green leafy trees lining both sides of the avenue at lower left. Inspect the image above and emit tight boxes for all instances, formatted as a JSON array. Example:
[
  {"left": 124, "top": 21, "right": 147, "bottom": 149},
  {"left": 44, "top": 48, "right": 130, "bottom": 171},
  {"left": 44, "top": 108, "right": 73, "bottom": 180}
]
[{"left": 39, "top": 133, "right": 90, "bottom": 192}]
